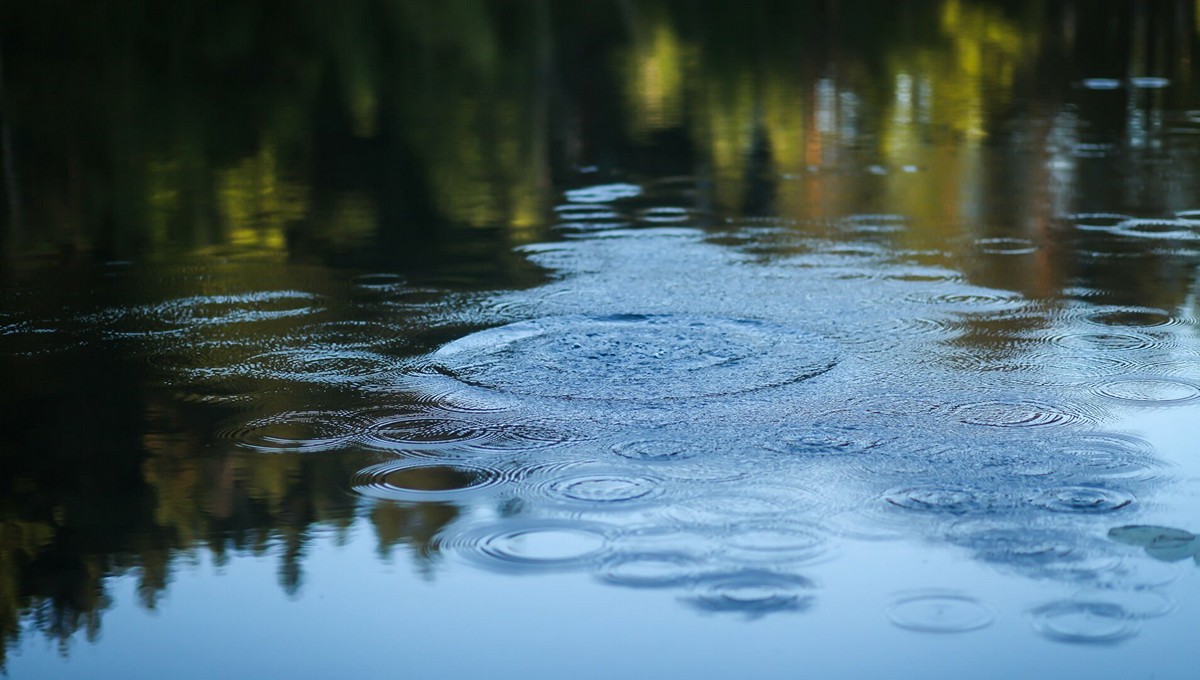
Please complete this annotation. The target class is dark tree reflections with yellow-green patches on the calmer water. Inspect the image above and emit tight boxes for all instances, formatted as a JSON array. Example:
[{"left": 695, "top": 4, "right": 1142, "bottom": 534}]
[{"left": 0, "top": 0, "right": 1200, "bottom": 666}]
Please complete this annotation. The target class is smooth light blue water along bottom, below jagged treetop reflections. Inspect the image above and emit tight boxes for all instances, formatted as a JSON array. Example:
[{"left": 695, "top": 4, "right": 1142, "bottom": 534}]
[{"left": 8, "top": 520, "right": 1200, "bottom": 679}]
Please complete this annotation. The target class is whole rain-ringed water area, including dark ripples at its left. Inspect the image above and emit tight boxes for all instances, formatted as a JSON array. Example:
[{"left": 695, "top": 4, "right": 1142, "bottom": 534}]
[{"left": 4, "top": 181, "right": 1200, "bottom": 643}]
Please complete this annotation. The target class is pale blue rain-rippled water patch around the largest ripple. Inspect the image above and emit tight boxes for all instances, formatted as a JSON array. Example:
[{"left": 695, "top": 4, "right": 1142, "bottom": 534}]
[{"left": 396, "top": 185, "right": 1194, "bottom": 642}]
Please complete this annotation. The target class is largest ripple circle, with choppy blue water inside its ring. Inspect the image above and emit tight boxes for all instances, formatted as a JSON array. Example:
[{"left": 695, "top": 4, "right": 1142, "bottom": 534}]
[{"left": 433, "top": 314, "right": 836, "bottom": 401}]
